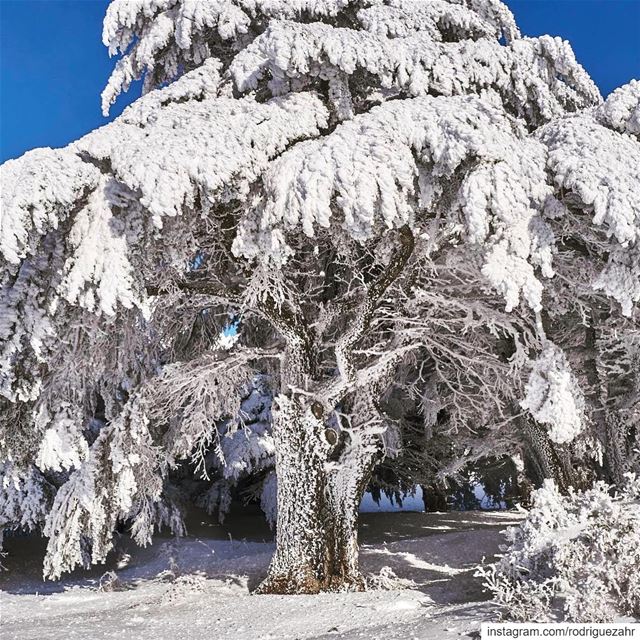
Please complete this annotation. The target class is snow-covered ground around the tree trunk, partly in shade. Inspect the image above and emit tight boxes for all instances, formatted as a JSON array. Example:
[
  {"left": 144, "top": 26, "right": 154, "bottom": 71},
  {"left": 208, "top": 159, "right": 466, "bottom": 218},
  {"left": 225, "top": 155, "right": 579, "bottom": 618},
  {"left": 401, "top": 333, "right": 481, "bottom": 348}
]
[{"left": 0, "top": 512, "right": 519, "bottom": 640}]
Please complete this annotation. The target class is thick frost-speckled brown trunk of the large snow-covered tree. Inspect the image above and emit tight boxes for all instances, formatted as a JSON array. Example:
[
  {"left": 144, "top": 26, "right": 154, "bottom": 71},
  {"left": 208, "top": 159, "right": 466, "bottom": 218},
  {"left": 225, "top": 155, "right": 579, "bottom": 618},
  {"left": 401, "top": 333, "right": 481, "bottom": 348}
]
[{"left": 256, "top": 396, "right": 375, "bottom": 594}]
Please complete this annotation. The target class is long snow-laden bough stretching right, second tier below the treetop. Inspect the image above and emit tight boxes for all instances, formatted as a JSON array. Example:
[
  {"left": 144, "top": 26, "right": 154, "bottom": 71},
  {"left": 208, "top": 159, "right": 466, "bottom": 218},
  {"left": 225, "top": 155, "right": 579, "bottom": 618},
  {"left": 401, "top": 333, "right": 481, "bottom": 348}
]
[{"left": 230, "top": 21, "right": 599, "bottom": 124}]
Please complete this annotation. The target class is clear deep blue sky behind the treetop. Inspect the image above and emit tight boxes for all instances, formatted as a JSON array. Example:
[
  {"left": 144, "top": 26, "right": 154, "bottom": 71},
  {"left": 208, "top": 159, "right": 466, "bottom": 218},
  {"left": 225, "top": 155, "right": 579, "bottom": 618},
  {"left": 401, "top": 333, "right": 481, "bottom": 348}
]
[{"left": 0, "top": 0, "right": 640, "bottom": 162}]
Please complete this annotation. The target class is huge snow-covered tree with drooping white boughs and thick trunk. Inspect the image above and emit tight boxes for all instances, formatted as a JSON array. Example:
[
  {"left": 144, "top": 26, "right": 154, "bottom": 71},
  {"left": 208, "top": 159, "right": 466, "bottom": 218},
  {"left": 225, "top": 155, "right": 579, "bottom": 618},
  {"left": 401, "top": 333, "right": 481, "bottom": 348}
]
[{"left": 0, "top": 0, "right": 640, "bottom": 593}]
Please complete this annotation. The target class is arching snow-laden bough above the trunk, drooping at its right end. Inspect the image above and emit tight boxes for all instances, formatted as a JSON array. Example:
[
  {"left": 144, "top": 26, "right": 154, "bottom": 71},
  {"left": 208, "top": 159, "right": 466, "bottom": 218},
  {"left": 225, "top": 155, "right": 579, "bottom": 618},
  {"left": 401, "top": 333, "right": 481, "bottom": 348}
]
[{"left": 234, "top": 98, "right": 553, "bottom": 309}]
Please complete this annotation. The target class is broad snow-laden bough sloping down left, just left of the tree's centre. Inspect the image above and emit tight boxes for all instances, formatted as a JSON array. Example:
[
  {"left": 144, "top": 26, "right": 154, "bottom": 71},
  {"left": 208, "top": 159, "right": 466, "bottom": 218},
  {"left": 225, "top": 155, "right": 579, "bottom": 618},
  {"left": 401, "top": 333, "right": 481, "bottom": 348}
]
[{"left": 79, "top": 93, "right": 327, "bottom": 221}]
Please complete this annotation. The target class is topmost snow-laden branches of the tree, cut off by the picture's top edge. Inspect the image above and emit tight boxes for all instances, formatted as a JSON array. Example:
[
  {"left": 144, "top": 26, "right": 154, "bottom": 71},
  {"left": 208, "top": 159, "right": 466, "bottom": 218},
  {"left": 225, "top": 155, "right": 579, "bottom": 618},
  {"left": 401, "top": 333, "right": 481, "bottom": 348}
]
[{"left": 102, "top": 0, "right": 519, "bottom": 113}]
